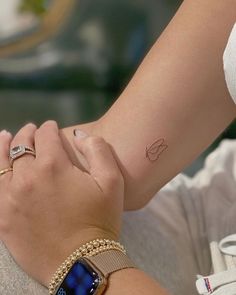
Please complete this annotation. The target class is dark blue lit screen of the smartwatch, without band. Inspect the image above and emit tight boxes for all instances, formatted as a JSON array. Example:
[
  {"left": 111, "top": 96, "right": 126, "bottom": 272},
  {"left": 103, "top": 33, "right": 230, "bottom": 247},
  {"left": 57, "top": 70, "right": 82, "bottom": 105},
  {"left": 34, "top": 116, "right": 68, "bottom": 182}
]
[{"left": 56, "top": 260, "right": 102, "bottom": 295}]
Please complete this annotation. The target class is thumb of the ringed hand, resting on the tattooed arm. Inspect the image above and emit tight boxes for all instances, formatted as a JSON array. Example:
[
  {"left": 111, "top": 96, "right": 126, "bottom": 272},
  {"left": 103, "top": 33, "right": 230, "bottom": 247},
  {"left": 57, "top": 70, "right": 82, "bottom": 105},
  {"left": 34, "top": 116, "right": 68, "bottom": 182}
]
[{"left": 74, "top": 130, "right": 123, "bottom": 191}]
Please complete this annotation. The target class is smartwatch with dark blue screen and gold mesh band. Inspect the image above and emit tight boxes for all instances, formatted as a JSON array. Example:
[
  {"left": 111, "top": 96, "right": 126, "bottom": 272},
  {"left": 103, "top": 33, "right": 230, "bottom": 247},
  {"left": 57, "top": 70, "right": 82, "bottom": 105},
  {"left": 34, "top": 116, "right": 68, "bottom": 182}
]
[{"left": 55, "top": 250, "right": 136, "bottom": 295}]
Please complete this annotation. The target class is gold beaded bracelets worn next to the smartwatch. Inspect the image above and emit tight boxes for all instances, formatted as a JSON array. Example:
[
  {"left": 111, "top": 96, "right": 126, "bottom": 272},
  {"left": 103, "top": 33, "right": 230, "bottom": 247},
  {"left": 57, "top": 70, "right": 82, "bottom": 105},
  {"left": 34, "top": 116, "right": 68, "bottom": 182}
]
[{"left": 49, "top": 239, "right": 126, "bottom": 295}]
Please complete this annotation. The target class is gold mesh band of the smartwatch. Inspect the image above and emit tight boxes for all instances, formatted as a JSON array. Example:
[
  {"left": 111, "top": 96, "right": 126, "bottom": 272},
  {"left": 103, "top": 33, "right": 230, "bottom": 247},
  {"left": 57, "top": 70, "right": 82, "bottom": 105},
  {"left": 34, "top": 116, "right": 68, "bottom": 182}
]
[{"left": 86, "top": 250, "right": 136, "bottom": 277}]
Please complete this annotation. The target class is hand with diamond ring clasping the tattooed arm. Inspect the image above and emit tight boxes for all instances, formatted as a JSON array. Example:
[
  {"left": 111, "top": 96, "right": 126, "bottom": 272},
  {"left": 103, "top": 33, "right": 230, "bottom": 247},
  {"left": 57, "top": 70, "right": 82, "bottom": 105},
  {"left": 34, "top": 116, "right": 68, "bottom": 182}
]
[{"left": 0, "top": 122, "right": 124, "bottom": 285}]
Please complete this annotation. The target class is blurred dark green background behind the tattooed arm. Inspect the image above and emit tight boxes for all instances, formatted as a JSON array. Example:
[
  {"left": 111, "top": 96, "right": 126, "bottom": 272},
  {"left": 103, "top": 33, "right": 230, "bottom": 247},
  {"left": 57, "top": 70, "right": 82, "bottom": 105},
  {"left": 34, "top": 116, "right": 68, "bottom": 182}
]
[{"left": 0, "top": 0, "right": 236, "bottom": 175}]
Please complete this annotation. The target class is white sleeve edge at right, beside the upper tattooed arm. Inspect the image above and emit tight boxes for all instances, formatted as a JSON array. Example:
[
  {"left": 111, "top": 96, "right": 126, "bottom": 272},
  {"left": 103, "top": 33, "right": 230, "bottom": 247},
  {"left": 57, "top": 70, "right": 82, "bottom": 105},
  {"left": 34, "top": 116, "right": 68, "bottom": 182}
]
[{"left": 223, "top": 24, "right": 236, "bottom": 103}]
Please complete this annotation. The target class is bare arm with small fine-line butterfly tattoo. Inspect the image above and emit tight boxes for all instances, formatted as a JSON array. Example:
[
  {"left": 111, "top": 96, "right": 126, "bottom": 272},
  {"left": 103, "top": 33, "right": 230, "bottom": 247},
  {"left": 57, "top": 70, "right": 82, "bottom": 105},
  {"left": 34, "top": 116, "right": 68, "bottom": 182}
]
[{"left": 63, "top": 0, "right": 236, "bottom": 209}]
